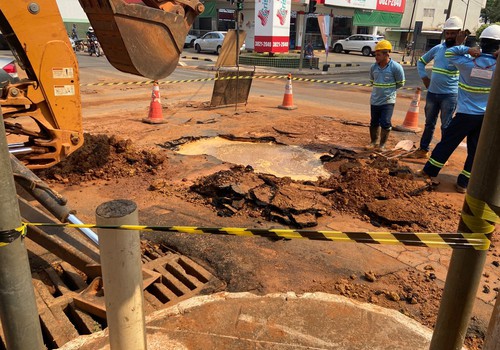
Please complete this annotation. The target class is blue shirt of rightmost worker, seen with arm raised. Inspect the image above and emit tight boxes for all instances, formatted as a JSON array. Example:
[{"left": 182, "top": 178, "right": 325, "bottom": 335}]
[{"left": 445, "top": 45, "right": 497, "bottom": 115}]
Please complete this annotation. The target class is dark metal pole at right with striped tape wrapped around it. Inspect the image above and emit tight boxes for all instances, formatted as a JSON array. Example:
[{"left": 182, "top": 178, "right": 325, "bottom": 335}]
[{"left": 430, "top": 42, "right": 500, "bottom": 350}]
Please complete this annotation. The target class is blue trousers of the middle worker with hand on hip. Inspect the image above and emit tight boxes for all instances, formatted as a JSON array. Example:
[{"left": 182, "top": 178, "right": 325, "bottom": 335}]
[{"left": 420, "top": 92, "right": 457, "bottom": 151}]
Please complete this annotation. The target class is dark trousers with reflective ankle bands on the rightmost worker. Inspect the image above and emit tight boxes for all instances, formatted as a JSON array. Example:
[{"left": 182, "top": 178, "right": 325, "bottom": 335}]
[{"left": 424, "top": 113, "right": 484, "bottom": 188}]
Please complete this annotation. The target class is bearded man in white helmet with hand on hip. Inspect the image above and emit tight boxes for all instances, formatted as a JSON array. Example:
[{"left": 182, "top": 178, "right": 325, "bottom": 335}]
[{"left": 410, "top": 16, "right": 463, "bottom": 158}]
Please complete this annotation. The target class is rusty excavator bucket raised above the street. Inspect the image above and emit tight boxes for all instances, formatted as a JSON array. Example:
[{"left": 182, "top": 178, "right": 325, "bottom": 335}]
[{"left": 79, "top": 0, "right": 204, "bottom": 80}]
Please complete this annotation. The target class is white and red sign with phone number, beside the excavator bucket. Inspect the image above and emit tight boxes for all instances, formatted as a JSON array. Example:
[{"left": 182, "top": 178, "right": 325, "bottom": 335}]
[{"left": 254, "top": 0, "right": 292, "bottom": 53}]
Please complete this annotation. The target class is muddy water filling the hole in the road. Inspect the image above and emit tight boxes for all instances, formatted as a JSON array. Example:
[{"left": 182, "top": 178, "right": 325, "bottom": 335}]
[{"left": 178, "top": 137, "right": 330, "bottom": 181}]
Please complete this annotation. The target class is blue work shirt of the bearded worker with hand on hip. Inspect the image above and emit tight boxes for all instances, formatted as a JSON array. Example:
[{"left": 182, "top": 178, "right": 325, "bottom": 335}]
[{"left": 417, "top": 43, "right": 459, "bottom": 95}]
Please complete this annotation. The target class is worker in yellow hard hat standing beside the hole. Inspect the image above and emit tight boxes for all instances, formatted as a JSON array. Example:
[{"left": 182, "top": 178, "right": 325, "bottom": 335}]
[{"left": 368, "top": 40, "right": 405, "bottom": 149}]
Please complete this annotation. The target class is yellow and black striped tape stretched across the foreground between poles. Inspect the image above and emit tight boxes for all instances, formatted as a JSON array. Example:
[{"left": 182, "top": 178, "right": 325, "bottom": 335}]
[{"left": 21, "top": 223, "right": 490, "bottom": 250}]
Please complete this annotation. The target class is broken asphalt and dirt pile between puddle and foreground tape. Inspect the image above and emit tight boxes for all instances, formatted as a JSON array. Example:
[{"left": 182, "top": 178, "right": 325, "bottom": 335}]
[{"left": 191, "top": 159, "right": 458, "bottom": 232}]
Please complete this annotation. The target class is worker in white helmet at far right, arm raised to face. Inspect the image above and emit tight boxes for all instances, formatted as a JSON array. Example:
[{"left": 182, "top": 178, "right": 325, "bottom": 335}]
[{"left": 421, "top": 24, "right": 500, "bottom": 193}]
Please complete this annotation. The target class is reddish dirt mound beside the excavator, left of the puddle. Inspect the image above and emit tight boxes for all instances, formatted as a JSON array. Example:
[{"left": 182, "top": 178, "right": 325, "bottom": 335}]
[{"left": 37, "top": 134, "right": 166, "bottom": 184}]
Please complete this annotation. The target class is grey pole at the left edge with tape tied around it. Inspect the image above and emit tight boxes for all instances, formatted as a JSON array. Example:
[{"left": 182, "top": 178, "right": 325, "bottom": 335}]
[{"left": 0, "top": 111, "right": 45, "bottom": 350}]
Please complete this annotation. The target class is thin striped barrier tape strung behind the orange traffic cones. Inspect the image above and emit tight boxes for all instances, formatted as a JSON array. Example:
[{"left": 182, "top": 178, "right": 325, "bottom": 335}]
[{"left": 80, "top": 75, "right": 415, "bottom": 90}]
